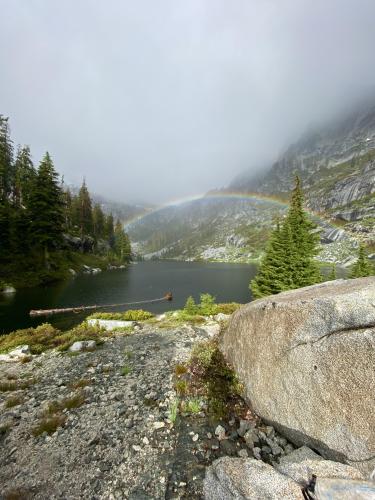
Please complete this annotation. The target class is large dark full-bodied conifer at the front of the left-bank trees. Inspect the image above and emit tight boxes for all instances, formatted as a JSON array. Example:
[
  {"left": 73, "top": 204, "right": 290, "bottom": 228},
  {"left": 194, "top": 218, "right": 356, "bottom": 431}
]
[{"left": 29, "top": 152, "right": 64, "bottom": 266}]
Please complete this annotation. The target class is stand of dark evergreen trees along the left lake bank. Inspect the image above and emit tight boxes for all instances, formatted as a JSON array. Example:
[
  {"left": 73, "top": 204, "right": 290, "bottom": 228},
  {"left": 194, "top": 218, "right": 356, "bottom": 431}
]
[{"left": 0, "top": 115, "right": 131, "bottom": 284}]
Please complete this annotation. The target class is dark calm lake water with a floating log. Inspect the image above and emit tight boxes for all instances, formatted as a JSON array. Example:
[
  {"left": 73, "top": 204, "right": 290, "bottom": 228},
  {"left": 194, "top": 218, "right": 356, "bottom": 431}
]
[{"left": 0, "top": 261, "right": 256, "bottom": 333}]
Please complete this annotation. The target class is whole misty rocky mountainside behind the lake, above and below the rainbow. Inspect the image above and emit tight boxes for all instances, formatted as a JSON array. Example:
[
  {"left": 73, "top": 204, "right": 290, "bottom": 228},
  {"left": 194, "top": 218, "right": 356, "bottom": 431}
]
[{"left": 128, "top": 103, "right": 375, "bottom": 263}]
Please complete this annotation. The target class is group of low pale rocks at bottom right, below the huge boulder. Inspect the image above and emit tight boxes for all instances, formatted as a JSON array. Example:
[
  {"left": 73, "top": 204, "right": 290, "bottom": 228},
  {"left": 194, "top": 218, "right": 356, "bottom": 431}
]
[{"left": 204, "top": 447, "right": 375, "bottom": 500}]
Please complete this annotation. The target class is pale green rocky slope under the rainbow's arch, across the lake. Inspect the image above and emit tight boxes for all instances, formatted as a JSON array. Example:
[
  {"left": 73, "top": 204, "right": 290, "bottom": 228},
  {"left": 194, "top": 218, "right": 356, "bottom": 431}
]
[{"left": 127, "top": 197, "right": 284, "bottom": 262}]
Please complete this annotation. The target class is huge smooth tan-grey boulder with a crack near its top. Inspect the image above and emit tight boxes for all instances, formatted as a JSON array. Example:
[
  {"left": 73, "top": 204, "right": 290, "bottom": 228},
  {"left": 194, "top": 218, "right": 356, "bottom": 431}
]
[{"left": 221, "top": 277, "right": 375, "bottom": 472}]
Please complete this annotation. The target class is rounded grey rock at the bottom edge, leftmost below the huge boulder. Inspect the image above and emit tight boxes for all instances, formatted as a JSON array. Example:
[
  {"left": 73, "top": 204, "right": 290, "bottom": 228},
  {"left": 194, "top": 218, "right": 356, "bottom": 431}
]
[{"left": 204, "top": 457, "right": 301, "bottom": 500}]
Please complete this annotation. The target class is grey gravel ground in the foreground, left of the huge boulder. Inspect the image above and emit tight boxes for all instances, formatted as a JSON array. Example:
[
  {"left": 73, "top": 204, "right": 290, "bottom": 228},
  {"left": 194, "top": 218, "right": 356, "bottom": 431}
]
[{"left": 0, "top": 326, "right": 293, "bottom": 500}]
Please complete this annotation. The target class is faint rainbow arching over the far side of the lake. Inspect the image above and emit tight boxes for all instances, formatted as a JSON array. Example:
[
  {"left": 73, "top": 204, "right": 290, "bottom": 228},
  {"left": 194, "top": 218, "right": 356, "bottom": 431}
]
[{"left": 125, "top": 191, "right": 335, "bottom": 228}]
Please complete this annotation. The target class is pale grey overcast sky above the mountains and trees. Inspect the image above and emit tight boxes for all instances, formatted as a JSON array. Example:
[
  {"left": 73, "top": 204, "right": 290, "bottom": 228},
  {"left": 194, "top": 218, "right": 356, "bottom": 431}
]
[{"left": 0, "top": 0, "right": 375, "bottom": 203}]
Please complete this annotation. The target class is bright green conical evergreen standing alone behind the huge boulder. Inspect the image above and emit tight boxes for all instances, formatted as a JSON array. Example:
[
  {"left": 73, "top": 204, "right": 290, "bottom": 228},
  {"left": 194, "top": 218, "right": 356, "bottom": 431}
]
[{"left": 250, "top": 177, "right": 321, "bottom": 298}]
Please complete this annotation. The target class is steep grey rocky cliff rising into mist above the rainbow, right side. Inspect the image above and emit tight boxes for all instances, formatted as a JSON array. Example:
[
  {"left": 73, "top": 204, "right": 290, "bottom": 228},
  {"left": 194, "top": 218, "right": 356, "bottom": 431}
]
[{"left": 229, "top": 103, "right": 375, "bottom": 242}]
